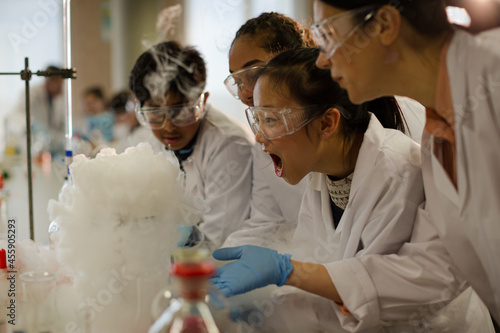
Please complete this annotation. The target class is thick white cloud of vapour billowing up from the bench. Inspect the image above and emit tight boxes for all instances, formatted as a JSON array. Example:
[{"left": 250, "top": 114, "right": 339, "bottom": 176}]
[{"left": 49, "top": 144, "right": 195, "bottom": 333}]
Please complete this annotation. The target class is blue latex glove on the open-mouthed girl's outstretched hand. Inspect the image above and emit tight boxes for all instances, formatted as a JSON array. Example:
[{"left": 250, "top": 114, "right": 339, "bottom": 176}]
[{"left": 210, "top": 245, "right": 293, "bottom": 296}]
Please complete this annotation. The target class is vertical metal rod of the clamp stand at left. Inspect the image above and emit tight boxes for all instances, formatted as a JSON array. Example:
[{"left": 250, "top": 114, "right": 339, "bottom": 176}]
[{"left": 21, "top": 58, "right": 35, "bottom": 241}]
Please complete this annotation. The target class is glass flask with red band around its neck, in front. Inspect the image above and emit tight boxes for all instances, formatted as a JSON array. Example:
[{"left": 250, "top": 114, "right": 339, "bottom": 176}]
[{"left": 148, "top": 248, "right": 230, "bottom": 333}]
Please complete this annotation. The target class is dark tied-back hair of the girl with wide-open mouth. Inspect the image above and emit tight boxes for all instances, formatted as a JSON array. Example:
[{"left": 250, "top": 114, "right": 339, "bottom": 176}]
[{"left": 260, "top": 48, "right": 405, "bottom": 153}]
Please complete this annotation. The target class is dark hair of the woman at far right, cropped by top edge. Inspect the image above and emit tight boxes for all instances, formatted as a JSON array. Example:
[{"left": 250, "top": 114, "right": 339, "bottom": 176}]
[{"left": 320, "top": 0, "right": 451, "bottom": 36}]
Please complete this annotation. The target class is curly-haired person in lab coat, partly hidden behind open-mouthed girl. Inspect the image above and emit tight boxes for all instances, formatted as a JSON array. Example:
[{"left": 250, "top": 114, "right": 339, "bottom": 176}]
[{"left": 223, "top": 12, "right": 313, "bottom": 249}]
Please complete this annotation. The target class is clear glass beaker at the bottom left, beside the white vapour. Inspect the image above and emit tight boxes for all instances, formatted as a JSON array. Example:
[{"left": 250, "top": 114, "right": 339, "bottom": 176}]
[{"left": 14, "top": 271, "right": 59, "bottom": 333}]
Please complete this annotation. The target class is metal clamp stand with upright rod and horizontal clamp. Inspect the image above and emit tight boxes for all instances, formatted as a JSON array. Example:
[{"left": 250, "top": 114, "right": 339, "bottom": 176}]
[{"left": 0, "top": 58, "right": 76, "bottom": 241}]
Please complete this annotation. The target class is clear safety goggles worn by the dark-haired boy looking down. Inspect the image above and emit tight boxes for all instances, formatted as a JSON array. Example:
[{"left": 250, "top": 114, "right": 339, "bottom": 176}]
[{"left": 135, "top": 94, "right": 205, "bottom": 129}]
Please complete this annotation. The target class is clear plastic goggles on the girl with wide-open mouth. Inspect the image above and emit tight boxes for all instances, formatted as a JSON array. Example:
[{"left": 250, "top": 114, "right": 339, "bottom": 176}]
[{"left": 245, "top": 107, "right": 314, "bottom": 140}]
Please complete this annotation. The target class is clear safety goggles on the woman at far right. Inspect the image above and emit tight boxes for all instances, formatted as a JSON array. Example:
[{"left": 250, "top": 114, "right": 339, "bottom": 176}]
[{"left": 311, "top": 6, "right": 376, "bottom": 58}]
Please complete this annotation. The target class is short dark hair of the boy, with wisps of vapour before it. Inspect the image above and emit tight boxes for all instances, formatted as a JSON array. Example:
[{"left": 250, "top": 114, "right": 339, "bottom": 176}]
[{"left": 129, "top": 41, "right": 207, "bottom": 105}]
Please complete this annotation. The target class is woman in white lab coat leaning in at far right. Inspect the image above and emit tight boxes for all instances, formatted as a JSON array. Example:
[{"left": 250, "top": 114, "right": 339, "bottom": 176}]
[{"left": 313, "top": 0, "right": 500, "bottom": 323}]
